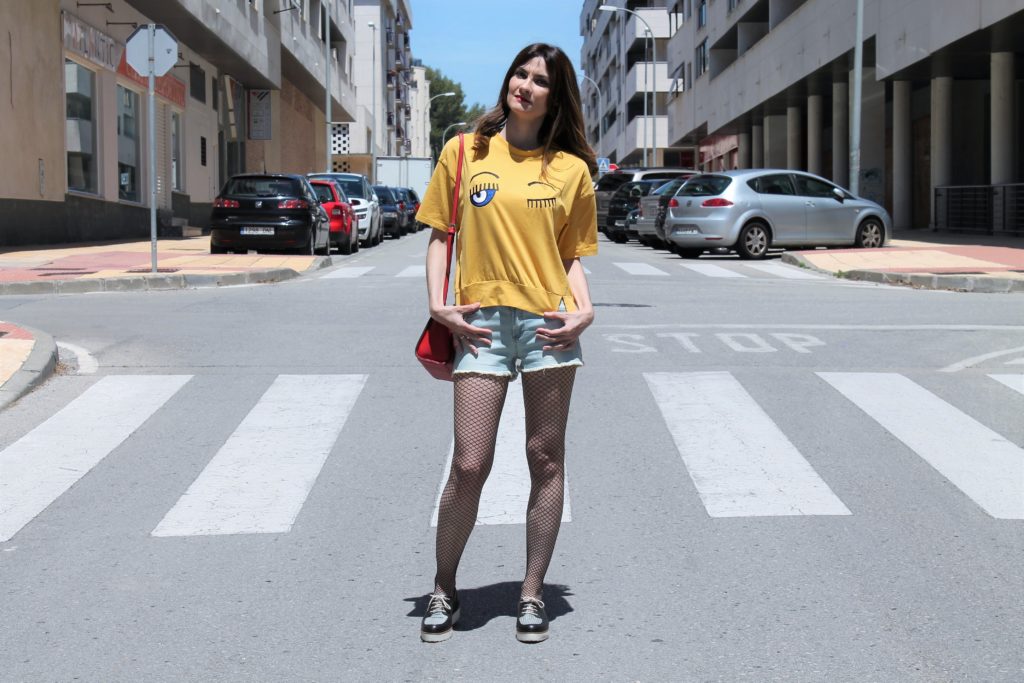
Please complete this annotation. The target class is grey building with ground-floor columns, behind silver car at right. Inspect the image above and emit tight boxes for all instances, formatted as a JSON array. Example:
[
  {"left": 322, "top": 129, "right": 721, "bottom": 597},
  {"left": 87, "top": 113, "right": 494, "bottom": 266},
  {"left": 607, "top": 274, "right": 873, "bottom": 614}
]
[{"left": 668, "top": 0, "right": 1024, "bottom": 230}]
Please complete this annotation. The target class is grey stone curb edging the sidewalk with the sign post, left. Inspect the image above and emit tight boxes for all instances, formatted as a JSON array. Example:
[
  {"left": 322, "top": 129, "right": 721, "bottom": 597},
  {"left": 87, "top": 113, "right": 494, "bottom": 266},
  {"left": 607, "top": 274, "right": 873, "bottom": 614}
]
[{"left": 0, "top": 256, "right": 334, "bottom": 296}]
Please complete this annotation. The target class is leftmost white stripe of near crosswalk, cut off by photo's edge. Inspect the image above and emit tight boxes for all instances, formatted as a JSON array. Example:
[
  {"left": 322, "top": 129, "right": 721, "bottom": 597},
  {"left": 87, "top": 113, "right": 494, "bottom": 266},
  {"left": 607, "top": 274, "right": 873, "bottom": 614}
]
[{"left": 0, "top": 375, "right": 191, "bottom": 542}]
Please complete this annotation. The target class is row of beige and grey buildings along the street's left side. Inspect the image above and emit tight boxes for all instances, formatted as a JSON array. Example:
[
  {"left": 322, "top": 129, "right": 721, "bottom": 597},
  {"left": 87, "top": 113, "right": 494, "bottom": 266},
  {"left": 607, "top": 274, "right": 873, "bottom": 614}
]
[{"left": 0, "top": 0, "right": 423, "bottom": 246}]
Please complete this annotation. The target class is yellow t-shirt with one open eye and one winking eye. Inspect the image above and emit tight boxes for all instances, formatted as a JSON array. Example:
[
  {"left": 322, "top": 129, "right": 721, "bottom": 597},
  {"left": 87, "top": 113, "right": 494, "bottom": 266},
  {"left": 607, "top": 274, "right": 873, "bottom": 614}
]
[{"left": 416, "top": 134, "right": 597, "bottom": 314}]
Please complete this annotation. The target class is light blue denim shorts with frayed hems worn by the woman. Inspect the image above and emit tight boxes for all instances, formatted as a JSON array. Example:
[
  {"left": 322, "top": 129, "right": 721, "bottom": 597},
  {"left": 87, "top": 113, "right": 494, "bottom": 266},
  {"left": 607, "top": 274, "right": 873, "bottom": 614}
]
[{"left": 454, "top": 304, "right": 583, "bottom": 380}]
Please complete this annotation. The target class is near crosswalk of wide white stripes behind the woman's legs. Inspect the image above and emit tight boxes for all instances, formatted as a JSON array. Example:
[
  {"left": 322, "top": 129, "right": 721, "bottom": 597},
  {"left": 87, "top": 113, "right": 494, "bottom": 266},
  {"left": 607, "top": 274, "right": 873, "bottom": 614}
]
[{"left": 0, "top": 371, "right": 1024, "bottom": 543}]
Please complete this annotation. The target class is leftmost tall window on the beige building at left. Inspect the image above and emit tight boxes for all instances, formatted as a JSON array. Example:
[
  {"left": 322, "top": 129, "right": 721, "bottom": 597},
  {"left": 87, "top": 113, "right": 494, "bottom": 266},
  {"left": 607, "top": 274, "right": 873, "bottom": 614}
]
[{"left": 65, "top": 59, "right": 97, "bottom": 193}]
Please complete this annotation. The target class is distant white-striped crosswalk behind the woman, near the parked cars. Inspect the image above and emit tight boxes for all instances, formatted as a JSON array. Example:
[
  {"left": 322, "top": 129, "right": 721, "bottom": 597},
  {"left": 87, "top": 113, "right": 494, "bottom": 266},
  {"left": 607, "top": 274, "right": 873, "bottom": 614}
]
[{"left": 322, "top": 259, "right": 829, "bottom": 282}]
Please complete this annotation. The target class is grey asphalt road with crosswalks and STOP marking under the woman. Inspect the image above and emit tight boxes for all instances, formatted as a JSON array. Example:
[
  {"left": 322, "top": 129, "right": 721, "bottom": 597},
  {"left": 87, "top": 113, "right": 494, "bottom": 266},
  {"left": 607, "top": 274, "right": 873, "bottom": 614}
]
[{"left": 0, "top": 233, "right": 1024, "bottom": 681}]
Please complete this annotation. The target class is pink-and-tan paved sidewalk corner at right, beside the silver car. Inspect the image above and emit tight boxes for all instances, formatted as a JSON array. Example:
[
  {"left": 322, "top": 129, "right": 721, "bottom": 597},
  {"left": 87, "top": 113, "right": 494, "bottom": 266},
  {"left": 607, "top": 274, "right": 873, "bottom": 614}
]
[{"left": 782, "top": 230, "right": 1024, "bottom": 292}]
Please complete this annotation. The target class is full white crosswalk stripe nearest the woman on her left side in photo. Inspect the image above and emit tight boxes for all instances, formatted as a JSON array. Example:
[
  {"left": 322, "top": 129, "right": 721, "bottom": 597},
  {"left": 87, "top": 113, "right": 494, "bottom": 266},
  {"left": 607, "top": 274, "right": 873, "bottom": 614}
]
[{"left": 153, "top": 375, "right": 367, "bottom": 537}]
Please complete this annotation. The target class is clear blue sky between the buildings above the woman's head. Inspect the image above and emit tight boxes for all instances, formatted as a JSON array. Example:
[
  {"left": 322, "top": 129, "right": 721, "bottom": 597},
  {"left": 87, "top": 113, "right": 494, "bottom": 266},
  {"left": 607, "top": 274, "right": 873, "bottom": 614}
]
[{"left": 411, "top": 0, "right": 583, "bottom": 109}]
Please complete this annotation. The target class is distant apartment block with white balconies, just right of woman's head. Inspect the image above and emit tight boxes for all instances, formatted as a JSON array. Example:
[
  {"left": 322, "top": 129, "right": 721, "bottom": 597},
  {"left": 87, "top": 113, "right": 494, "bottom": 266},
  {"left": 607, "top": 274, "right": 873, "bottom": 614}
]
[{"left": 580, "top": 0, "right": 692, "bottom": 166}]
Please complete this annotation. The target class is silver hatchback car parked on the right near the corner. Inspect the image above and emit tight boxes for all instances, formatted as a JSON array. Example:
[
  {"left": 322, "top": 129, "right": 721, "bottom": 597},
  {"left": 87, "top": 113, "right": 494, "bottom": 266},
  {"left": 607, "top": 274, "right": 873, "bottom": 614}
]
[{"left": 665, "top": 169, "right": 892, "bottom": 259}]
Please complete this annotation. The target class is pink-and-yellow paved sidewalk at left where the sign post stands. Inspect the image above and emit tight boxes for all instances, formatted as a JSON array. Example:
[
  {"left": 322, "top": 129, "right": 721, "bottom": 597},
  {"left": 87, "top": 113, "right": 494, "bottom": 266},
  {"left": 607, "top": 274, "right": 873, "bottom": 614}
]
[{"left": 0, "top": 237, "right": 331, "bottom": 294}]
